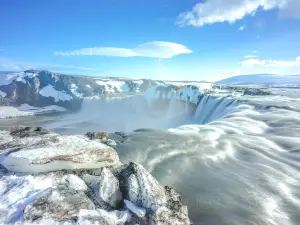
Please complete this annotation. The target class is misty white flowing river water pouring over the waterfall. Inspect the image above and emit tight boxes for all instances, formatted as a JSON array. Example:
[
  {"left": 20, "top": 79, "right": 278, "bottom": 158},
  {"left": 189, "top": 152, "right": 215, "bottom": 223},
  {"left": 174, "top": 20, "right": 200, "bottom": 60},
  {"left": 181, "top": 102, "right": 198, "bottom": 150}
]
[{"left": 3, "top": 90, "right": 300, "bottom": 225}]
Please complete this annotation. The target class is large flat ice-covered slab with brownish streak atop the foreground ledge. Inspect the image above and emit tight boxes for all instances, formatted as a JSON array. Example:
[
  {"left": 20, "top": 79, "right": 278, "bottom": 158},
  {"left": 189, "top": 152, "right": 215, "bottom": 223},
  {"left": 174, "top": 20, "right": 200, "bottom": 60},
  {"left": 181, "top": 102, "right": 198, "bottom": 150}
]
[{"left": 1, "top": 131, "right": 119, "bottom": 173}]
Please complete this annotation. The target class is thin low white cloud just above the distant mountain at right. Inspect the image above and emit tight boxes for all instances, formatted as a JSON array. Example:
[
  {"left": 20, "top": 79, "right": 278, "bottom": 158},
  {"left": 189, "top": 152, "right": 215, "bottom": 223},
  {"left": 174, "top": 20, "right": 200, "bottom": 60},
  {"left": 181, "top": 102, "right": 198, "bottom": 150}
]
[{"left": 240, "top": 57, "right": 300, "bottom": 67}]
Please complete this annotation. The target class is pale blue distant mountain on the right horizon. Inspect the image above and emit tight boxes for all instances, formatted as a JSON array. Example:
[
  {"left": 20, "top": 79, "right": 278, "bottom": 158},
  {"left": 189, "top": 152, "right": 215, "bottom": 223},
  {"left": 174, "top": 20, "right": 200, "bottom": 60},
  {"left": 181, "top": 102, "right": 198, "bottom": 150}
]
[{"left": 216, "top": 74, "right": 300, "bottom": 85}]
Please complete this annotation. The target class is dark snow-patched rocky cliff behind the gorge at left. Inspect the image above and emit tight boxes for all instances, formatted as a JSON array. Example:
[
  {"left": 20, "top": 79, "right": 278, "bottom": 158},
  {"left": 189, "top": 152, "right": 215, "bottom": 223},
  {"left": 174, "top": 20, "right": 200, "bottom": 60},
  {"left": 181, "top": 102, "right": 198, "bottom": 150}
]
[{"left": 0, "top": 70, "right": 158, "bottom": 110}]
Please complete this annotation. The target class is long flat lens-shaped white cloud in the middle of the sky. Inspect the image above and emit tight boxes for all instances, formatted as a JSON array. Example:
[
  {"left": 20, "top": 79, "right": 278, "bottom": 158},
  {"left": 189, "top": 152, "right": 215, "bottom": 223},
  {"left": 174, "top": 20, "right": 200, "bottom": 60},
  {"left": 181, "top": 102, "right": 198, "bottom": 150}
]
[{"left": 54, "top": 41, "right": 192, "bottom": 59}]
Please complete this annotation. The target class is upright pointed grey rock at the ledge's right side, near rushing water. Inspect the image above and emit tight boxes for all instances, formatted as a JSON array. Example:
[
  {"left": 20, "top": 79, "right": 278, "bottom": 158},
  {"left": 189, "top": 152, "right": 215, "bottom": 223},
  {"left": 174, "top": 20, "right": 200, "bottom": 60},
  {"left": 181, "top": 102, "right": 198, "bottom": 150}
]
[{"left": 119, "top": 162, "right": 167, "bottom": 212}]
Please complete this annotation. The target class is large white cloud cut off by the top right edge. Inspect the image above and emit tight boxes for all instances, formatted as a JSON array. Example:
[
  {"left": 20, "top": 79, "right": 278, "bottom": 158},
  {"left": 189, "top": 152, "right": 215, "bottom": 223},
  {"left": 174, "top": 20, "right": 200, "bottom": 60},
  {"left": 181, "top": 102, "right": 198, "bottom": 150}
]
[{"left": 177, "top": 0, "right": 300, "bottom": 27}]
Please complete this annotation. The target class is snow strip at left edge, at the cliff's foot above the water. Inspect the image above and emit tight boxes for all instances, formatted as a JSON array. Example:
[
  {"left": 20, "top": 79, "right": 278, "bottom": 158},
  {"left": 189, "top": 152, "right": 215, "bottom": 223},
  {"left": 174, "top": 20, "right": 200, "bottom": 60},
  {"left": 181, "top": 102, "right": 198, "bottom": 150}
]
[{"left": 0, "top": 104, "right": 66, "bottom": 119}]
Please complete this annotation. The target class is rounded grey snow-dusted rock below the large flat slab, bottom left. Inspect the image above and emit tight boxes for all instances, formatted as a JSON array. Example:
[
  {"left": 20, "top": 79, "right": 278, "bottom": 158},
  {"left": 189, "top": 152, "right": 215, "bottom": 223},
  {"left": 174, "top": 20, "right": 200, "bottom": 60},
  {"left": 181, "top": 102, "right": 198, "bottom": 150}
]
[{"left": 24, "top": 185, "right": 95, "bottom": 222}]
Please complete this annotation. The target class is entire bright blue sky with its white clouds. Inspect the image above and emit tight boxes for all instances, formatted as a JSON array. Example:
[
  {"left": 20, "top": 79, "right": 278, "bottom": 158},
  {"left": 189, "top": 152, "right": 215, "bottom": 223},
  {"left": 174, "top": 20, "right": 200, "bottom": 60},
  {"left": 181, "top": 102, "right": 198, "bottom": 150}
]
[{"left": 0, "top": 0, "right": 300, "bottom": 81}]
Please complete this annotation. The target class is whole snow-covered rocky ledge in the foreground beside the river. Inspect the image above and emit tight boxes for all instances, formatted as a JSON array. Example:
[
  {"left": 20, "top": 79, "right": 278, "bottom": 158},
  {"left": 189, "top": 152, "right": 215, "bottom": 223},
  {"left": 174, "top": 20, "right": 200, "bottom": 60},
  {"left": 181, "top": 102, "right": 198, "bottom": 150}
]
[{"left": 0, "top": 127, "right": 191, "bottom": 225}]
